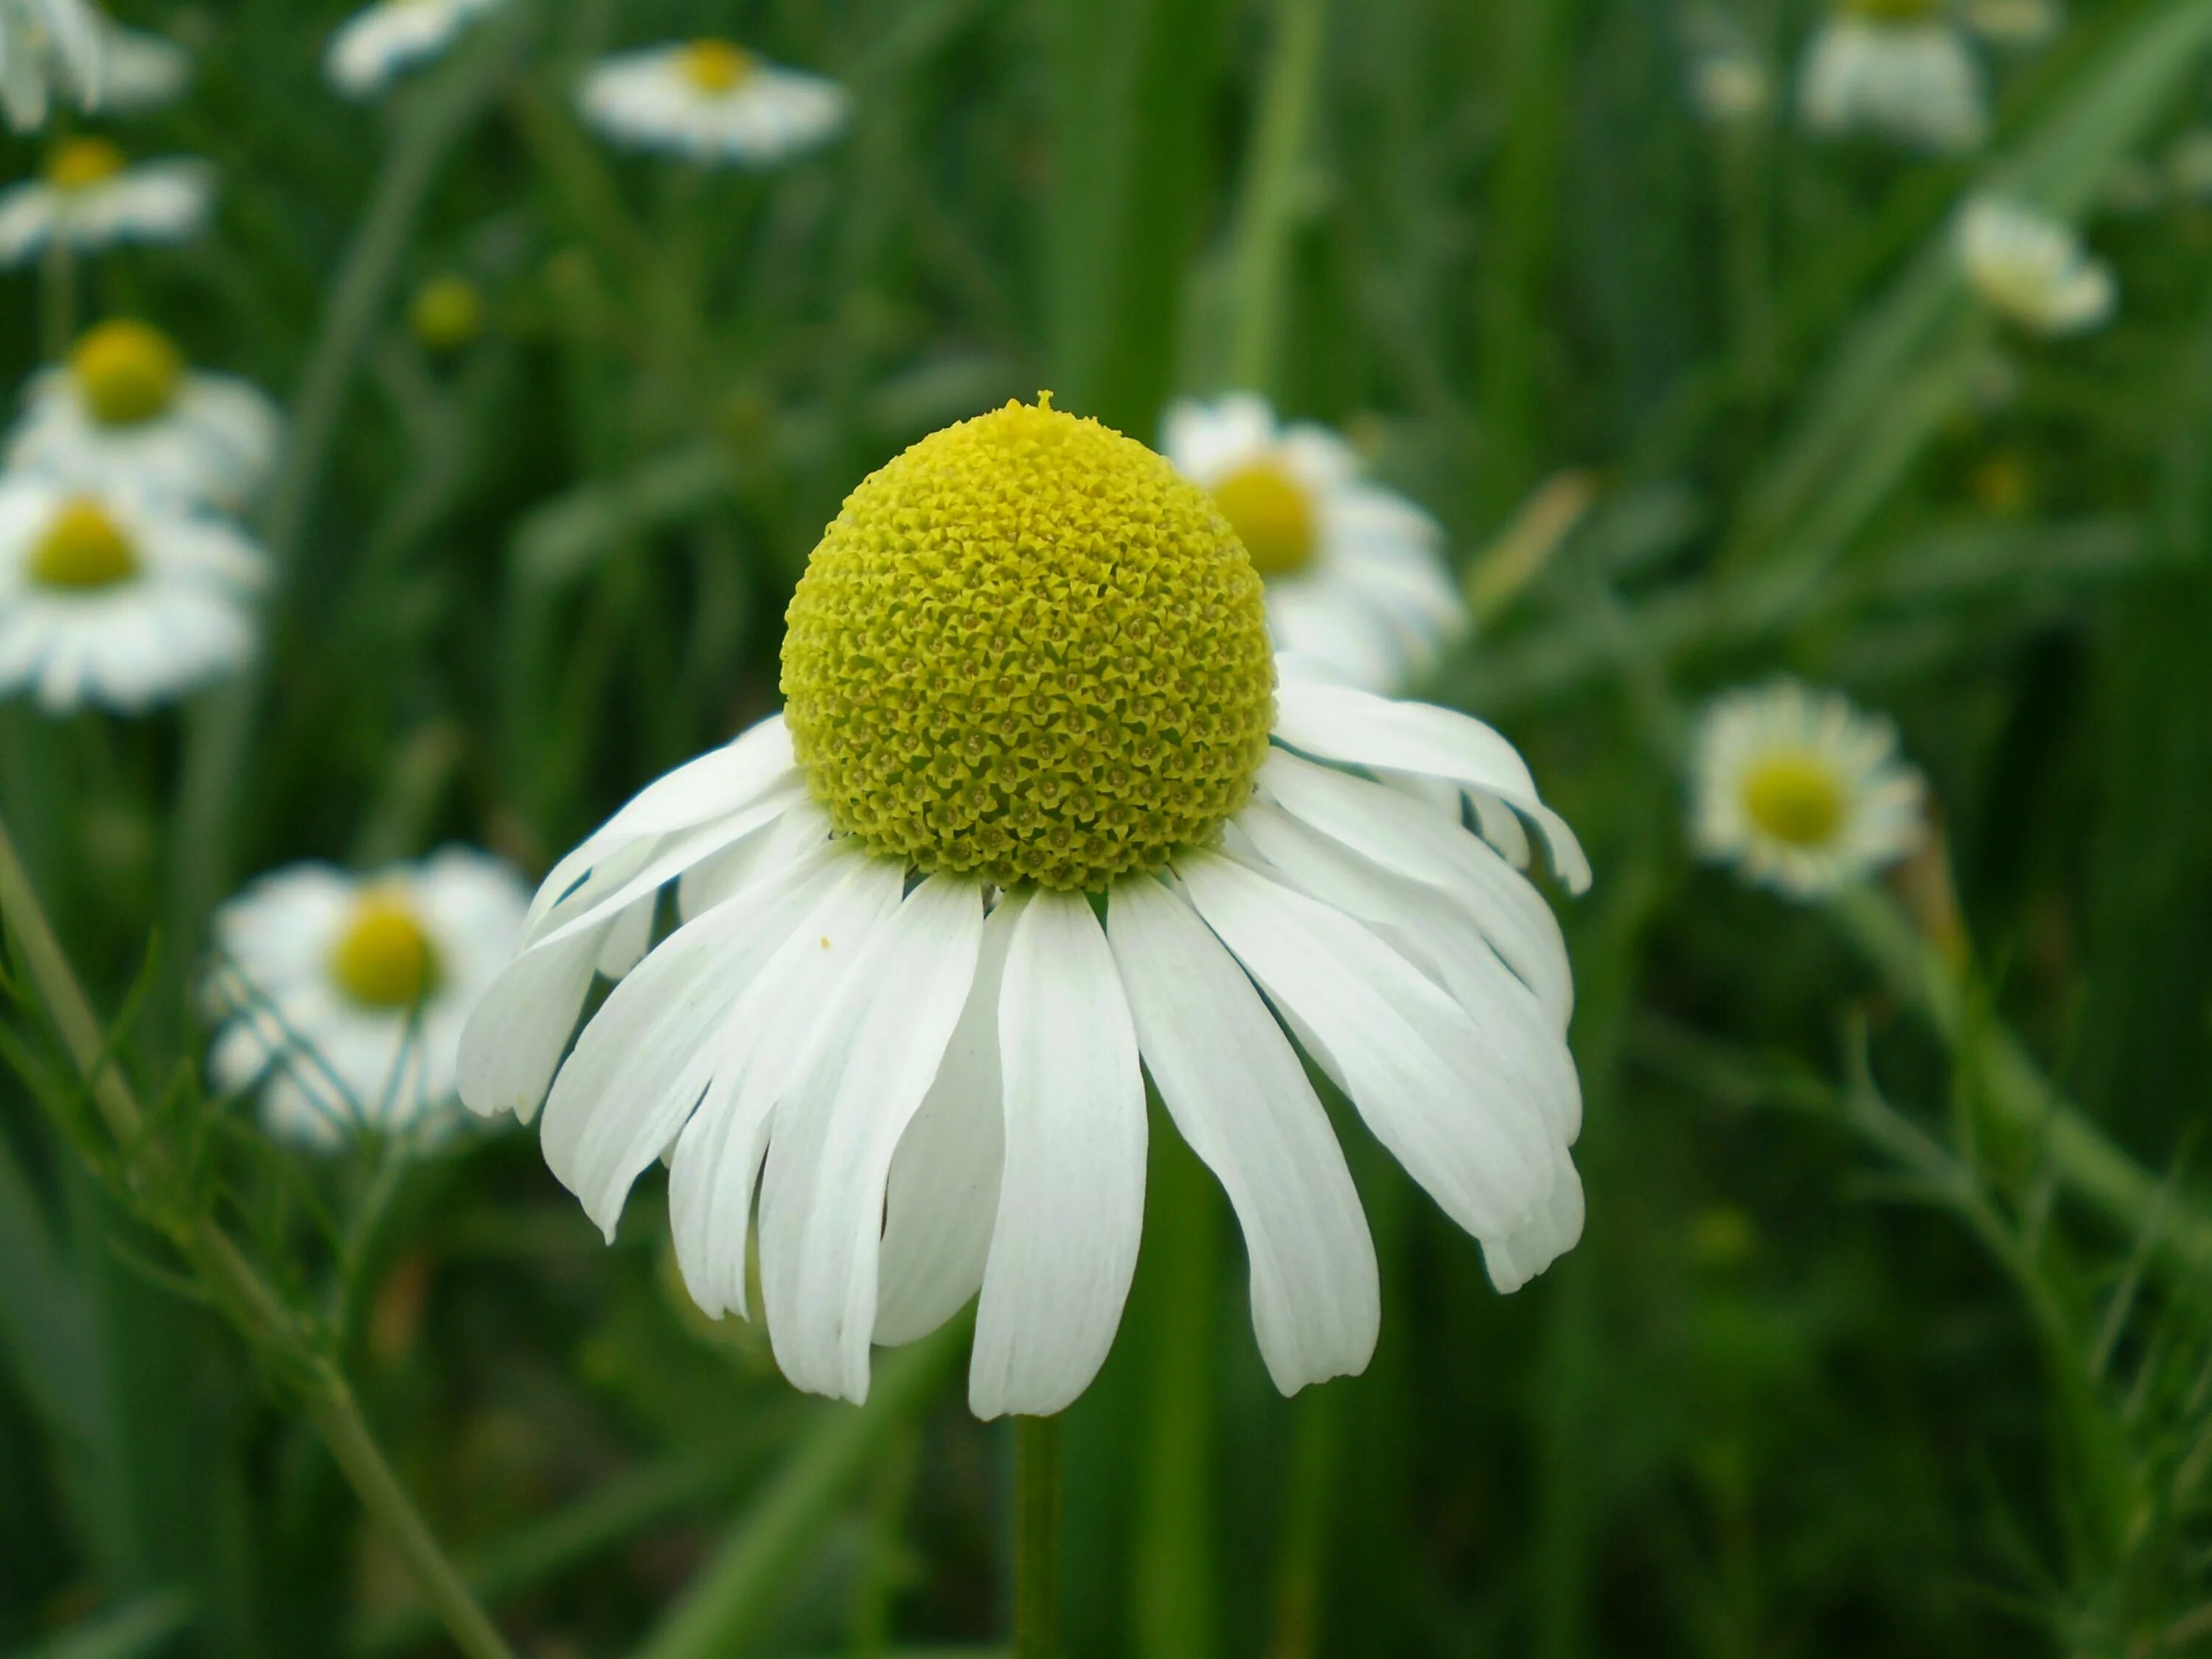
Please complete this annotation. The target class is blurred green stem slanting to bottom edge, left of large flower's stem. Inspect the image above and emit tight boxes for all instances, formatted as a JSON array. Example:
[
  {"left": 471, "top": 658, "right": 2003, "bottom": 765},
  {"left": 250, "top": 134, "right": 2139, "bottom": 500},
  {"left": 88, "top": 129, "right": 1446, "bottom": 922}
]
[{"left": 637, "top": 1321, "right": 967, "bottom": 1659}]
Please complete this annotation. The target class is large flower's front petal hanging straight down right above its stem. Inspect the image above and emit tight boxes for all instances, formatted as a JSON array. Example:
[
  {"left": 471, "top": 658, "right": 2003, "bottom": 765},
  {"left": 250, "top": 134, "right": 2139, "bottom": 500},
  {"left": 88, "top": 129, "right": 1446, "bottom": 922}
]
[{"left": 969, "top": 891, "right": 1146, "bottom": 1418}]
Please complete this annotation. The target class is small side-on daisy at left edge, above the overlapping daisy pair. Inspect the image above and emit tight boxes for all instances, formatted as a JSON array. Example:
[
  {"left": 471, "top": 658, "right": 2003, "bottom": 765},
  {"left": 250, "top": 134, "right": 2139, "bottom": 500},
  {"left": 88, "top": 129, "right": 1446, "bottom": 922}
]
[{"left": 0, "top": 137, "right": 215, "bottom": 265}]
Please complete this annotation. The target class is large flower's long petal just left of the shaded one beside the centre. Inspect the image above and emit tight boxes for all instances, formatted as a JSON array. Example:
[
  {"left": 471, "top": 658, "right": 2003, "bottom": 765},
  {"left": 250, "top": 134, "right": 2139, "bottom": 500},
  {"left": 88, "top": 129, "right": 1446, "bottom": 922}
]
[{"left": 761, "top": 876, "right": 982, "bottom": 1400}]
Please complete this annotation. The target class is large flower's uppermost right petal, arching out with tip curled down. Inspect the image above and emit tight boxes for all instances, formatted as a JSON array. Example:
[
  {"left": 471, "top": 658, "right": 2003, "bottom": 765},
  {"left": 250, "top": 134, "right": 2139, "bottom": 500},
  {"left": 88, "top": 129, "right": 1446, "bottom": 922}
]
[{"left": 1274, "top": 681, "right": 1590, "bottom": 894}]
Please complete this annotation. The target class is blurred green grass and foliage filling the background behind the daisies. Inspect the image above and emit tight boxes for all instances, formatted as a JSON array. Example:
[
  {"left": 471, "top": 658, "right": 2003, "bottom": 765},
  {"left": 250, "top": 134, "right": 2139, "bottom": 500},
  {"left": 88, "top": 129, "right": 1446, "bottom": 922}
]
[{"left": 0, "top": 0, "right": 2212, "bottom": 1659}]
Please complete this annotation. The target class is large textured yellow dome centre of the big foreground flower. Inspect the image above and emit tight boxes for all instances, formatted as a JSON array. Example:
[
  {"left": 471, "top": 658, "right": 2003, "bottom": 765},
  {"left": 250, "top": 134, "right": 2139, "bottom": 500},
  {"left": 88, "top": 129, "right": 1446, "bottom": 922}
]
[{"left": 783, "top": 398, "right": 1274, "bottom": 891}]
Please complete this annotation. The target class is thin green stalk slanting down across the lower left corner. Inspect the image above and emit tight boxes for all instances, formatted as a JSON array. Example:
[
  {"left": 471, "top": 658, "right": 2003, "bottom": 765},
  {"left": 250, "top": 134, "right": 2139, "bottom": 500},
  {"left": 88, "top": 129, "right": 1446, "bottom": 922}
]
[{"left": 0, "top": 823, "right": 513, "bottom": 1659}]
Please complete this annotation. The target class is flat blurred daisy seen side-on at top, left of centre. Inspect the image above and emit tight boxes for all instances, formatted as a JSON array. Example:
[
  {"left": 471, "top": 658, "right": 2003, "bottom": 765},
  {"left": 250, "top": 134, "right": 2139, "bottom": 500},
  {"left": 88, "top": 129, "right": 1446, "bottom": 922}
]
[{"left": 580, "top": 40, "right": 847, "bottom": 166}]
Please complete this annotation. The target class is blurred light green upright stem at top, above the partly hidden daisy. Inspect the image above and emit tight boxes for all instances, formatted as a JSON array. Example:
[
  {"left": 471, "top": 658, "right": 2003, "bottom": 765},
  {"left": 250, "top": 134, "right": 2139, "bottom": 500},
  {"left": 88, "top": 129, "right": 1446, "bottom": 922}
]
[{"left": 1230, "top": 0, "right": 1329, "bottom": 392}]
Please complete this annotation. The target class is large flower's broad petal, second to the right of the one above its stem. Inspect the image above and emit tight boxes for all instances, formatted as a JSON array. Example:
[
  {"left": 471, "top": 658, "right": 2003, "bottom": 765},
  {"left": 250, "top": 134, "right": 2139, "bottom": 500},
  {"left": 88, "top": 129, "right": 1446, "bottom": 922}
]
[{"left": 1175, "top": 854, "right": 1553, "bottom": 1237}]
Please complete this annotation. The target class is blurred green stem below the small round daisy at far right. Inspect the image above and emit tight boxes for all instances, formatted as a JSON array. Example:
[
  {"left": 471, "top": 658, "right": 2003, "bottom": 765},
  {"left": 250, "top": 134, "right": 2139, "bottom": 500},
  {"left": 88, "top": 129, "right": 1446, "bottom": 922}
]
[{"left": 1829, "top": 887, "right": 2212, "bottom": 1272}]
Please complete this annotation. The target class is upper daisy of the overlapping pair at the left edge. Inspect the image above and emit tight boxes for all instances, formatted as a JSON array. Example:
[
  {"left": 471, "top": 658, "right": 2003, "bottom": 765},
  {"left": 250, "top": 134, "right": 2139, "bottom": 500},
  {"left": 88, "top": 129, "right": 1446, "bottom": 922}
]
[{"left": 7, "top": 319, "right": 281, "bottom": 511}]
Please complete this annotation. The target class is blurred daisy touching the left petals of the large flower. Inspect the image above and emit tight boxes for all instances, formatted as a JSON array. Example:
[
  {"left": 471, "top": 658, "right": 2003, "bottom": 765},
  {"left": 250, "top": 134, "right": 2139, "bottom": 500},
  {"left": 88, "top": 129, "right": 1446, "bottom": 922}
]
[{"left": 208, "top": 847, "right": 529, "bottom": 1148}]
